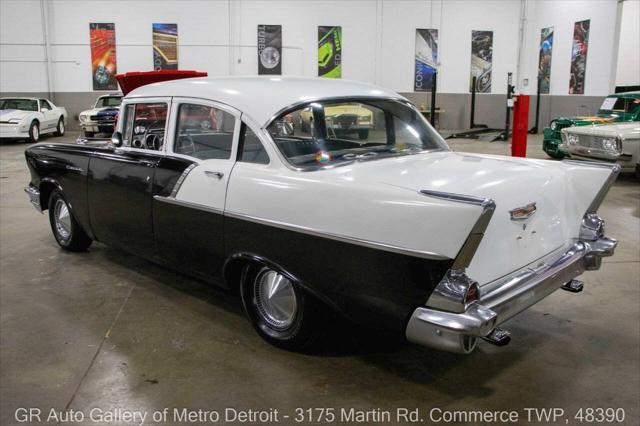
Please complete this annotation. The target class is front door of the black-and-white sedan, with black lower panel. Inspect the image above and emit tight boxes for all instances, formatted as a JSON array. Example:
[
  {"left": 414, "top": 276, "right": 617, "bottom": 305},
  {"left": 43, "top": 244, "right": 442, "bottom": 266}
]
[{"left": 88, "top": 98, "right": 170, "bottom": 259}]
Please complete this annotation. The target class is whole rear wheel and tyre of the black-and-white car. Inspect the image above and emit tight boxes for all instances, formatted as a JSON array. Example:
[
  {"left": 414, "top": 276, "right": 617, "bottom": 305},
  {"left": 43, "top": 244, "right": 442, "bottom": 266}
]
[{"left": 240, "top": 265, "right": 322, "bottom": 350}]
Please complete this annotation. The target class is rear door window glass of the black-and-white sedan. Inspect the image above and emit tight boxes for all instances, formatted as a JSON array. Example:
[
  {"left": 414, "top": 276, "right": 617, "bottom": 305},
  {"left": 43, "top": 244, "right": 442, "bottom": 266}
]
[{"left": 173, "top": 104, "right": 236, "bottom": 160}]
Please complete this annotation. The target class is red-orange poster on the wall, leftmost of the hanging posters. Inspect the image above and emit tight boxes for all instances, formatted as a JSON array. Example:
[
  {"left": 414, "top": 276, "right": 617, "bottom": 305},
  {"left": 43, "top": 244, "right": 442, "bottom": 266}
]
[{"left": 89, "top": 23, "right": 118, "bottom": 90}]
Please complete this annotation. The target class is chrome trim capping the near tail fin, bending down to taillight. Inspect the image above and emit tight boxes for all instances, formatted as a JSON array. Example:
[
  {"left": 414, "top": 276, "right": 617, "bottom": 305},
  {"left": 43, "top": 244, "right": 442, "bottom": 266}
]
[{"left": 420, "top": 189, "right": 496, "bottom": 270}]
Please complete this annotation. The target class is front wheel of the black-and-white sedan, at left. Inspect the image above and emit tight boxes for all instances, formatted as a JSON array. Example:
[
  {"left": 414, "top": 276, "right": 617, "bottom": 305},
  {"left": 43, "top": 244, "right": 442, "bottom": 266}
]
[{"left": 49, "top": 189, "right": 93, "bottom": 251}]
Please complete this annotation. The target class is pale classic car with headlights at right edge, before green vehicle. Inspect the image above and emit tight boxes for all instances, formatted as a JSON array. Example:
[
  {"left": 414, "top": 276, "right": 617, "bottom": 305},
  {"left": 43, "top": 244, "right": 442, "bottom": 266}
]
[{"left": 562, "top": 121, "right": 640, "bottom": 179}]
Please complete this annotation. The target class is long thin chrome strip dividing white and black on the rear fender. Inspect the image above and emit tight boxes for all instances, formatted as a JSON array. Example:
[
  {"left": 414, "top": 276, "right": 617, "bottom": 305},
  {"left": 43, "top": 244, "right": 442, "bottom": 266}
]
[{"left": 224, "top": 210, "right": 450, "bottom": 260}]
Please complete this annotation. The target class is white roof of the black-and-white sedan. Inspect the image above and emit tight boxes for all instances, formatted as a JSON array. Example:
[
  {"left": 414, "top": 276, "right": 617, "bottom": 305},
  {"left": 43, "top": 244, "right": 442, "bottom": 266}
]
[{"left": 126, "top": 76, "right": 404, "bottom": 125}]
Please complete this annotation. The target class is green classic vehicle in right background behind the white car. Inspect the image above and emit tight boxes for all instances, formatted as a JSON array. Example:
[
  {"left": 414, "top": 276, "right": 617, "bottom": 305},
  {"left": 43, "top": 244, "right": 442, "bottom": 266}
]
[{"left": 542, "top": 92, "right": 640, "bottom": 158}]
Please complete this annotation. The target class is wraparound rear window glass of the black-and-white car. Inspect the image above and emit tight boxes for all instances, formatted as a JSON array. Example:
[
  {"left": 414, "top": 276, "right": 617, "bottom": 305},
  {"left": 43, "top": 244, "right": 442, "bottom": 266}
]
[{"left": 267, "top": 99, "right": 449, "bottom": 168}]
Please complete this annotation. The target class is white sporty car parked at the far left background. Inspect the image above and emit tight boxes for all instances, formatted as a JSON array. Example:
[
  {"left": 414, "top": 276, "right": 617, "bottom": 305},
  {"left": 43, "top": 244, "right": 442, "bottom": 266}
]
[{"left": 0, "top": 98, "right": 67, "bottom": 142}]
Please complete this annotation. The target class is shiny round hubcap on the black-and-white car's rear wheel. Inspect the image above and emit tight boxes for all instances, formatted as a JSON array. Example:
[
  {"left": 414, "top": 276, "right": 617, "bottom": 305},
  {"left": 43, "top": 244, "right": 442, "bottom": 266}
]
[{"left": 254, "top": 268, "right": 298, "bottom": 330}]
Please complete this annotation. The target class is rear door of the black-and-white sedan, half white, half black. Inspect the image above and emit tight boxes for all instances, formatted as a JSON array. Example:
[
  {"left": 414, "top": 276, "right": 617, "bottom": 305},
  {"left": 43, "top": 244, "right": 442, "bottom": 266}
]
[{"left": 153, "top": 98, "right": 240, "bottom": 281}]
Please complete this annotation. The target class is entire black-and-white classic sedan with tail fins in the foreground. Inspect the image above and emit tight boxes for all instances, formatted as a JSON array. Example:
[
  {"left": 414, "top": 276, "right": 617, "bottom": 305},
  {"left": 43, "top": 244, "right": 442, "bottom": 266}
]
[{"left": 26, "top": 77, "right": 619, "bottom": 353}]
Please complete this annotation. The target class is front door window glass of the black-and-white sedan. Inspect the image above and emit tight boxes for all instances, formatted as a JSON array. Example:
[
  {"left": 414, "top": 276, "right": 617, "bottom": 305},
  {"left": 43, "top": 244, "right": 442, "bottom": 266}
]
[{"left": 122, "top": 102, "right": 168, "bottom": 151}]
